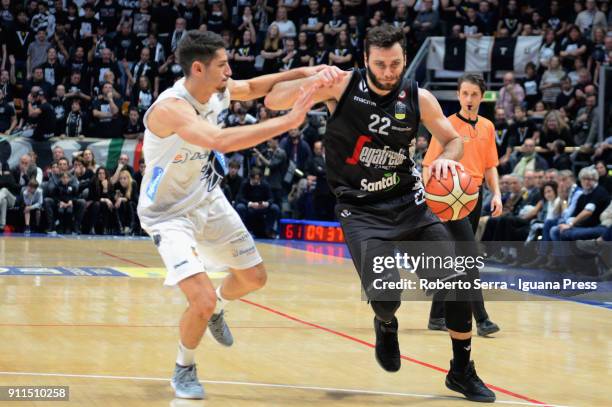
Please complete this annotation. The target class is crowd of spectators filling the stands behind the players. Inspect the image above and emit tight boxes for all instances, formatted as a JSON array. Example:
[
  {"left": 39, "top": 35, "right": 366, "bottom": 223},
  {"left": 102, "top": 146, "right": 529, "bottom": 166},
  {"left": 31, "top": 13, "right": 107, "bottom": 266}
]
[{"left": 0, "top": 0, "right": 612, "bottom": 274}]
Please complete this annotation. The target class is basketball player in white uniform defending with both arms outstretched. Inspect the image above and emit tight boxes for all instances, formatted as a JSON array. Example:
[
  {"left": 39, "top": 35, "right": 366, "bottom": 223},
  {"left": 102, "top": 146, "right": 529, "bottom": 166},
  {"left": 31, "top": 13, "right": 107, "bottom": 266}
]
[{"left": 138, "top": 31, "right": 342, "bottom": 399}]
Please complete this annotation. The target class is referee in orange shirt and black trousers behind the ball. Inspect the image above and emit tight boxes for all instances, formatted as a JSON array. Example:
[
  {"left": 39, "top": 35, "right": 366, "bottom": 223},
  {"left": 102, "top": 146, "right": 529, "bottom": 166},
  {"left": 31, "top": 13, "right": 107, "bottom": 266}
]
[{"left": 423, "top": 74, "right": 502, "bottom": 336}]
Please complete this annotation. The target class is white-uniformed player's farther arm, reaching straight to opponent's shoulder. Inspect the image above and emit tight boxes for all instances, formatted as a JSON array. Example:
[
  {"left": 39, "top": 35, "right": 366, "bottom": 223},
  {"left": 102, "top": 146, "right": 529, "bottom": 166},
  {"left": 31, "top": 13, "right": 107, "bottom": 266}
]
[{"left": 228, "top": 65, "right": 334, "bottom": 100}]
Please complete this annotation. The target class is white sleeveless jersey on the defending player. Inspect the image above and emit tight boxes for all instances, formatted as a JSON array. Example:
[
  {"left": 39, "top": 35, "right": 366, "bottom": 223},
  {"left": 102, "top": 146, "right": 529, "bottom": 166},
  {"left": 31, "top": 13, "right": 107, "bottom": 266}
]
[{"left": 138, "top": 78, "right": 230, "bottom": 227}]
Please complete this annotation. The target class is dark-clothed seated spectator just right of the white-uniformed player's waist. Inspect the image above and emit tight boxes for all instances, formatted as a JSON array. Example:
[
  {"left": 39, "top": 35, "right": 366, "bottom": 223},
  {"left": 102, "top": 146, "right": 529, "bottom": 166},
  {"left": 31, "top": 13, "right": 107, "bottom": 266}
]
[{"left": 236, "top": 167, "right": 280, "bottom": 239}]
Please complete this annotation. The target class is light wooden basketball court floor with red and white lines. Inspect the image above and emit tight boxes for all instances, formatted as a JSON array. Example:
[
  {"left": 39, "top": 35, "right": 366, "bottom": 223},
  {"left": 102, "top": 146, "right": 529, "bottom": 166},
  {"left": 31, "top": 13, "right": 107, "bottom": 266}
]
[{"left": 0, "top": 237, "right": 612, "bottom": 407}]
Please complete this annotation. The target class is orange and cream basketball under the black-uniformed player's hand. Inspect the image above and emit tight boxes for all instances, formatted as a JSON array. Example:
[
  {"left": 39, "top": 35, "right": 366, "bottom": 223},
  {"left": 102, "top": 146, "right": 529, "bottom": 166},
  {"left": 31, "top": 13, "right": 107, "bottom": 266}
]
[{"left": 425, "top": 168, "right": 479, "bottom": 221}]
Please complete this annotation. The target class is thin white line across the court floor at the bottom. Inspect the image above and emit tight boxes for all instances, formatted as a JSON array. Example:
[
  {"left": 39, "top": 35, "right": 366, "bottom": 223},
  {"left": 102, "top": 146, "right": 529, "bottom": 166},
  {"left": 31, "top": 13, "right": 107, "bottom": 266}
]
[{"left": 0, "top": 372, "right": 569, "bottom": 407}]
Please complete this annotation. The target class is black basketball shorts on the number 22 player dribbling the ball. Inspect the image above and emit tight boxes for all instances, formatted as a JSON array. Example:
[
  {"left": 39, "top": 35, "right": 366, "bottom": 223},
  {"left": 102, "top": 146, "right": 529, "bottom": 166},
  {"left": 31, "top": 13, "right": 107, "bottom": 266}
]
[{"left": 335, "top": 195, "right": 454, "bottom": 301}]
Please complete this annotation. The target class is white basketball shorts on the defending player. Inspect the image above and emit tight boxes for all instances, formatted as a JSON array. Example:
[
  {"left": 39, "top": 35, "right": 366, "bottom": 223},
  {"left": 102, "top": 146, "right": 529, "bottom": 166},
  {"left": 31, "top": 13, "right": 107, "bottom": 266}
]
[{"left": 143, "top": 188, "right": 262, "bottom": 286}]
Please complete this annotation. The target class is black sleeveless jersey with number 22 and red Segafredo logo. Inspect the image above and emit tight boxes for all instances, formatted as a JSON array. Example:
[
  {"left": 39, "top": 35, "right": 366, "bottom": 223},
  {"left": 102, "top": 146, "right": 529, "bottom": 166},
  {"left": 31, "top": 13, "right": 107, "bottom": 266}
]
[{"left": 325, "top": 69, "right": 424, "bottom": 207}]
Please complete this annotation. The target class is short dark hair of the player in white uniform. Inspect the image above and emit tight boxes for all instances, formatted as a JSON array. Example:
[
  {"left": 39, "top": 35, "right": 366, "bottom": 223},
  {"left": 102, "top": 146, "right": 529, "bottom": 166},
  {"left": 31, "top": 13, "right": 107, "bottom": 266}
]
[{"left": 176, "top": 30, "right": 225, "bottom": 76}]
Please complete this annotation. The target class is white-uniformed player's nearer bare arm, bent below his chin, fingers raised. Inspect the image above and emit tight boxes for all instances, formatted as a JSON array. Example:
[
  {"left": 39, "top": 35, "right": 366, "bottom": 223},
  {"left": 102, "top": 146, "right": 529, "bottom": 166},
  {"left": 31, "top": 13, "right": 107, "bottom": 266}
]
[{"left": 147, "top": 88, "right": 314, "bottom": 153}]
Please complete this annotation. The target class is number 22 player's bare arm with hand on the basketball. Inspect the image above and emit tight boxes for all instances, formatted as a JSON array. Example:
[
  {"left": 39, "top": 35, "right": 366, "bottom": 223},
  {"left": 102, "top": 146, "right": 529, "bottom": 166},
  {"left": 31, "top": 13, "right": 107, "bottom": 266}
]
[{"left": 419, "top": 89, "right": 463, "bottom": 178}]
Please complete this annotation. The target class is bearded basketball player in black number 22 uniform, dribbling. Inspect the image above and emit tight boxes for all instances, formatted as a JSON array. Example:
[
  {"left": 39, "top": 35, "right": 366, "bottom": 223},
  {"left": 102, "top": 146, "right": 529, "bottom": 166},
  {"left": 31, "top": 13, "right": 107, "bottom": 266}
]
[{"left": 266, "top": 25, "right": 495, "bottom": 402}]
